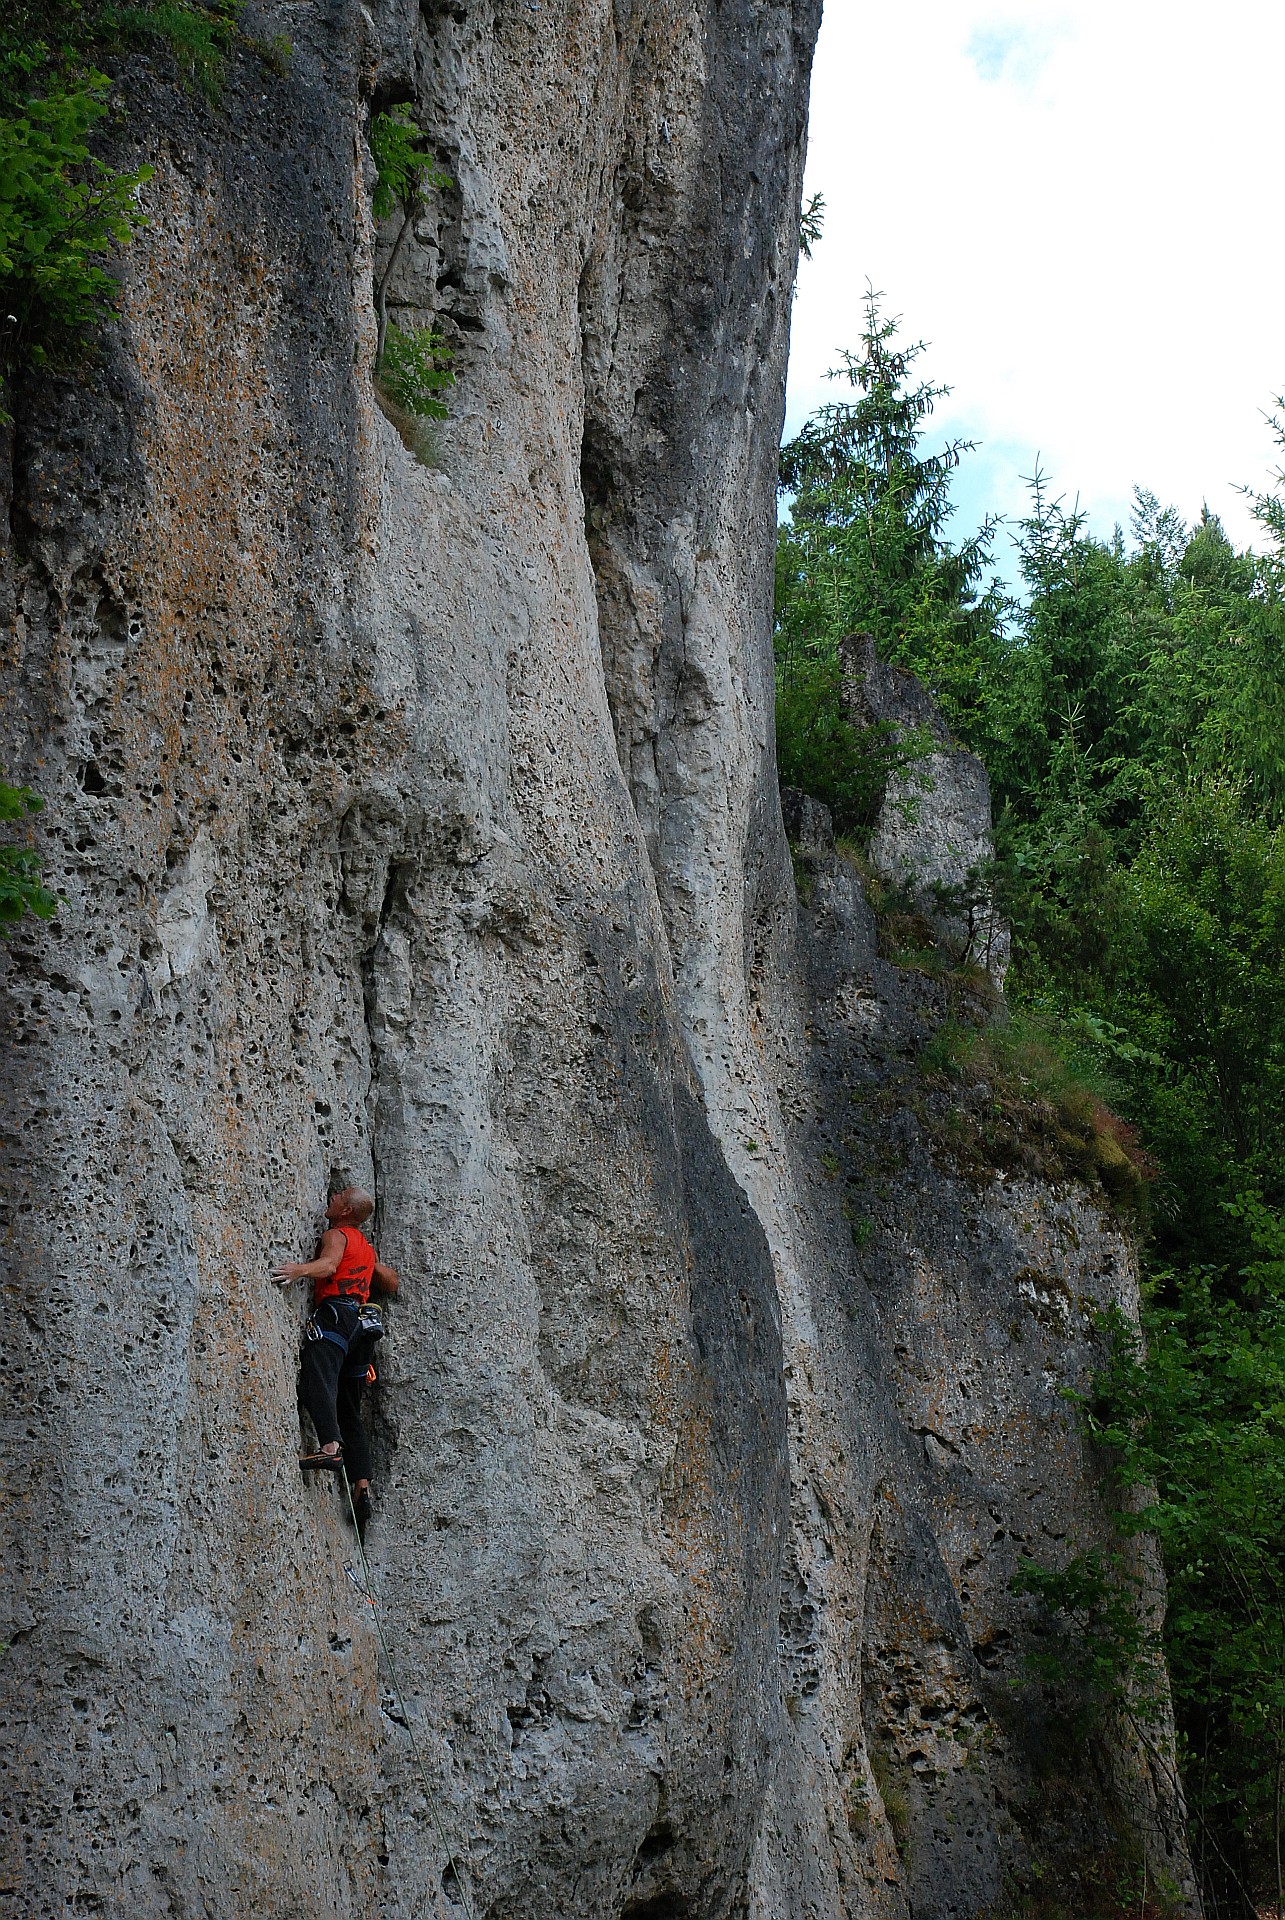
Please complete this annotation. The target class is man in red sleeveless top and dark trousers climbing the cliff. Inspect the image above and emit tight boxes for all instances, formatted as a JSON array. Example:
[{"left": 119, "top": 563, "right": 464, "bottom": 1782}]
[{"left": 273, "top": 1187, "right": 398, "bottom": 1536}]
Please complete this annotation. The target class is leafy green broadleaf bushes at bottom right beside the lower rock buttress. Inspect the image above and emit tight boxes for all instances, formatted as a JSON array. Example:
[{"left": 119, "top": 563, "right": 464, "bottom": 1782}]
[{"left": 1087, "top": 1259, "right": 1285, "bottom": 1907}]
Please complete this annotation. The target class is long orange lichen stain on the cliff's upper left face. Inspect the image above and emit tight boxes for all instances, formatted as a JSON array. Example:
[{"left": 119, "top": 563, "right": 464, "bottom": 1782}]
[{"left": 103, "top": 165, "right": 311, "bottom": 848}]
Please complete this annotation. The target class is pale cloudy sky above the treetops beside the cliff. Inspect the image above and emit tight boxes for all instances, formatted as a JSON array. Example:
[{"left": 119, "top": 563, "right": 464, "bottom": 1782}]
[{"left": 786, "top": 0, "right": 1285, "bottom": 570}]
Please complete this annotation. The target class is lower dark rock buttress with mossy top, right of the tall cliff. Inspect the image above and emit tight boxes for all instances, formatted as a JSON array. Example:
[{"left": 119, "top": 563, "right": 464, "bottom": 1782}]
[{"left": 786, "top": 798, "right": 1199, "bottom": 1916}]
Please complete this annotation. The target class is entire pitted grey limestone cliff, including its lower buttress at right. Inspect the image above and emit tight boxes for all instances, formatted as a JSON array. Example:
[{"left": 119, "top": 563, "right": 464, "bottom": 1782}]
[{"left": 0, "top": 0, "right": 1181, "bottom": 1920}]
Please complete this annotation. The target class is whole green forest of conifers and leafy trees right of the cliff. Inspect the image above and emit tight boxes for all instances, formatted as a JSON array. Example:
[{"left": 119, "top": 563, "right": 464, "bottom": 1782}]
[{"left": 776, "top": 294, "right": 1285, "bottom": 1914}]
